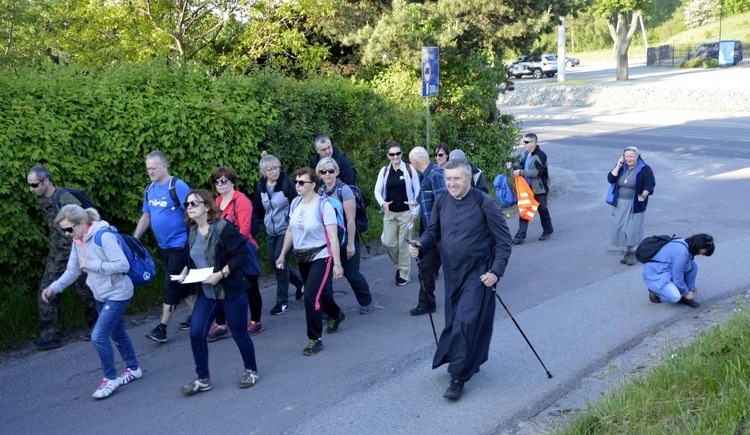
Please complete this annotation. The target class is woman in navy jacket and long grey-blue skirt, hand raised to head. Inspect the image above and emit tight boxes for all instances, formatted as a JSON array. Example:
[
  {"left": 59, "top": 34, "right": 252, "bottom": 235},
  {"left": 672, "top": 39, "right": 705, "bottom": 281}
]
[{"left": 607, "top": 147, "right": 656, "bottom": 266}]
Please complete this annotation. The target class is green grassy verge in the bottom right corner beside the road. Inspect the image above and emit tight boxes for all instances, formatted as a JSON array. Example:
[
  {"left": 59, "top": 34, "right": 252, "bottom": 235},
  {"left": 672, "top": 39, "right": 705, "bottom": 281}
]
[{"left": 559, "top": 307, "right": 750, "bottom": 434}]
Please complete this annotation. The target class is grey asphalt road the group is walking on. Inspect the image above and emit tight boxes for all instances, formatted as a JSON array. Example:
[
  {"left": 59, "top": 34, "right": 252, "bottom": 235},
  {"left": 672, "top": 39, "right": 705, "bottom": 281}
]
[{"left": 0, "top": 63, "right": 750, "bottom": 434}]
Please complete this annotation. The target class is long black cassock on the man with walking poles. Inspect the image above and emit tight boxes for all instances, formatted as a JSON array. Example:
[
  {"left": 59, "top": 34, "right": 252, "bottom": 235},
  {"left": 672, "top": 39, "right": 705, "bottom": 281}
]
[{"left": 419, "top": 188, "right": 511, "bottom": 382}]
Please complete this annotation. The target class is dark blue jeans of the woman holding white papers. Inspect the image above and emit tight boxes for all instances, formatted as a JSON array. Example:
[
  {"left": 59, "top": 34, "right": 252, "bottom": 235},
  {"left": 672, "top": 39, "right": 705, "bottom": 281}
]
[{"left": 190, "top": 292, "right": 258, "bottom": 379}]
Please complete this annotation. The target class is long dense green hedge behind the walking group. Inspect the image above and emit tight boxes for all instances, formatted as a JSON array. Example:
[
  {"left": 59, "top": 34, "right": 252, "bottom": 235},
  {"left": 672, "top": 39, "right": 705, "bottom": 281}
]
[{"left": 0, "top": 62, "right": 514, "bottom": 347}]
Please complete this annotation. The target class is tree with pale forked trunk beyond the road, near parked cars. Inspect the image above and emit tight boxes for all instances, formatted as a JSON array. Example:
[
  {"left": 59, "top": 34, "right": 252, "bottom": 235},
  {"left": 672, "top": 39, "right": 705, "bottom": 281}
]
[{"left": 593, "top": 0, "right": 650, "bottom": 81}]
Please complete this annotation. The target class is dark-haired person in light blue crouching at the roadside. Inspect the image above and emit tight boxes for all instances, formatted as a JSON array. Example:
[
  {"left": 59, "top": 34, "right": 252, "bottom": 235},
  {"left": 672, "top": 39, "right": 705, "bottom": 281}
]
[{"left": 643, "top": 233, "right": 715, "bottom": 308}]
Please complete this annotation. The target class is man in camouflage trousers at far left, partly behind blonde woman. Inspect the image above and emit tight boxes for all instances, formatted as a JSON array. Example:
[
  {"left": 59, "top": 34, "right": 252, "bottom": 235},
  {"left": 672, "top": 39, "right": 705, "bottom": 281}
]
[{"left": 26, "top": 166, "right": 99, "bottom": 350}]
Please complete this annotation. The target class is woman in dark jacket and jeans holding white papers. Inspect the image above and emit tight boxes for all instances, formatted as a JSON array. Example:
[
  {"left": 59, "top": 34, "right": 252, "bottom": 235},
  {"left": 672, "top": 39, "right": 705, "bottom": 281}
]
[{"left": 179, "top": 189, "right": 260, "bottom": 395}]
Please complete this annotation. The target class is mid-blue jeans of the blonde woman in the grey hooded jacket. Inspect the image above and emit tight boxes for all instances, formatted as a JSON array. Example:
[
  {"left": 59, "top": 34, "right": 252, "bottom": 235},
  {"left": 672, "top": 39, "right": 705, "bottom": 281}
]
[{"left": 91, "top": 299, "right": 139, "bottom": 379}]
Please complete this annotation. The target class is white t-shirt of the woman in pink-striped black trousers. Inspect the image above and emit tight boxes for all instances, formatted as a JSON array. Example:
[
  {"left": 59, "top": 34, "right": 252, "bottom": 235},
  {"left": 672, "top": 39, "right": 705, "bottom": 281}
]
[{"left": 289, "top": 200, "right": 337, "bottom": 260}]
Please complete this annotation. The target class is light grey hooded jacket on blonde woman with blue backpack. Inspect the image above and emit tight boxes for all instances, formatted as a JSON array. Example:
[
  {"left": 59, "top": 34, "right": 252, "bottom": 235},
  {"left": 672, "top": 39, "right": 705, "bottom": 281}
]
[{"left": 50, "top": 220, "right": 133, "bottom": 302}]
